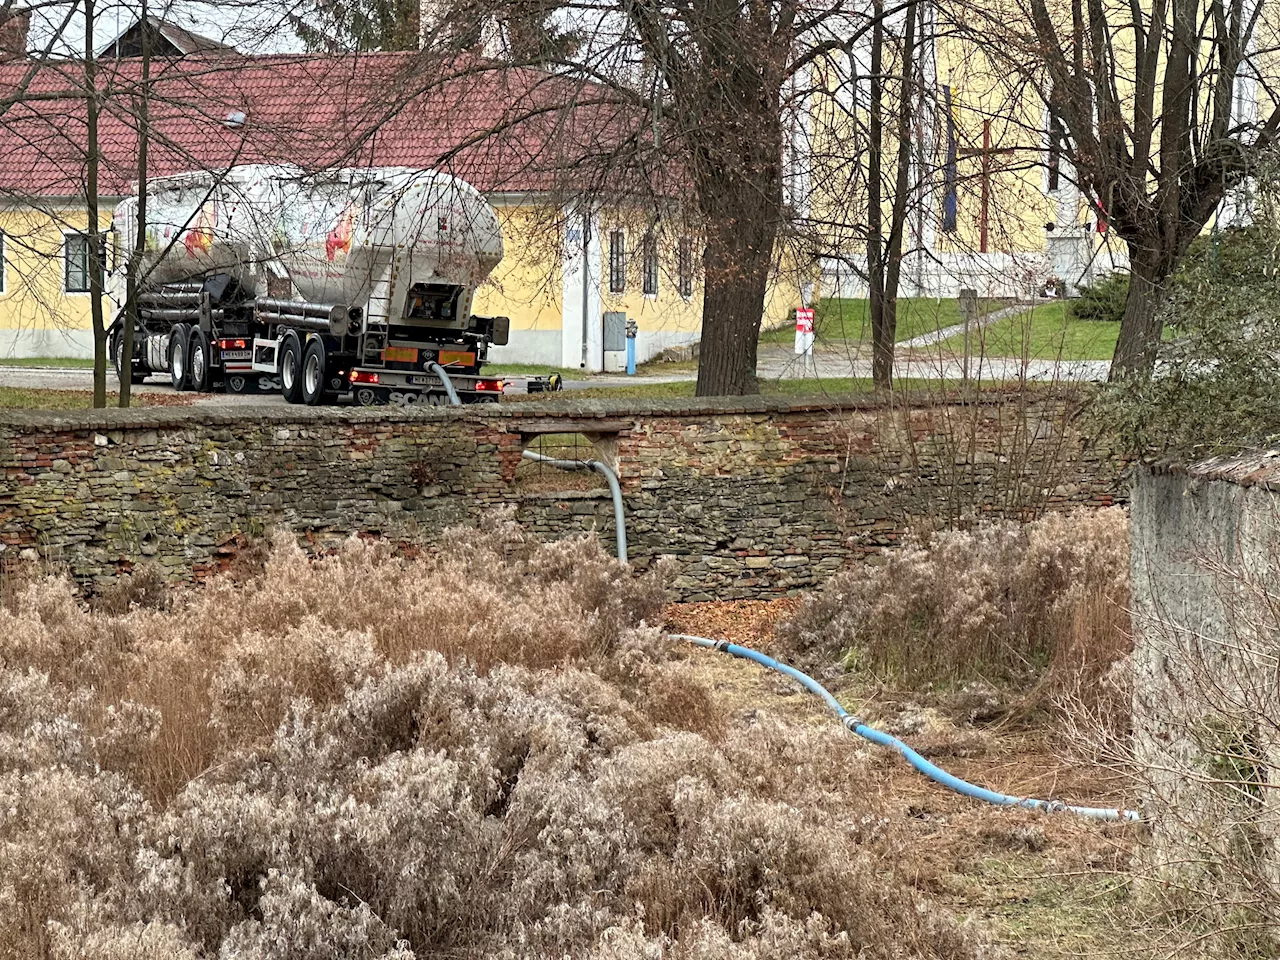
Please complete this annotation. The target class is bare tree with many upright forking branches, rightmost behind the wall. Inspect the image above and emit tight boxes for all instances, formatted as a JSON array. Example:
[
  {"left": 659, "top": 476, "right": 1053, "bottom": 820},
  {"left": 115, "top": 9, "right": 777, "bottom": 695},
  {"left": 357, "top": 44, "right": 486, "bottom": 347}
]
[{"left": 968, "top": 0, "right": 1280, "bottom": 378}]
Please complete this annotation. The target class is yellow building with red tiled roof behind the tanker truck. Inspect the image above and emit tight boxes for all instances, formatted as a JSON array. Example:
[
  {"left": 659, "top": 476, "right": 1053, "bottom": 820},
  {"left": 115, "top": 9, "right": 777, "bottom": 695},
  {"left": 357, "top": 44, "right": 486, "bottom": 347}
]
[{"left": 0, "top": 39, "right": 800, "bottom": 371}]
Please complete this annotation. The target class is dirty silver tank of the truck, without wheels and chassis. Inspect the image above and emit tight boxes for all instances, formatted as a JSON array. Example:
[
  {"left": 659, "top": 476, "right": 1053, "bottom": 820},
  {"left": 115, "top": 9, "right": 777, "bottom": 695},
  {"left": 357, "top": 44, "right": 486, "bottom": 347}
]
[{"left": 113, "top": 165, "right": 502, "bottom": 329}]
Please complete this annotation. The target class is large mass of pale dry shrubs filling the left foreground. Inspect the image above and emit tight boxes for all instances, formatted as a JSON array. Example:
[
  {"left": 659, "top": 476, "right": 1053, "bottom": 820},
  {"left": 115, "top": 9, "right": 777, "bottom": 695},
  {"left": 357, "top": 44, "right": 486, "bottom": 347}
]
[{"left": 0, "top": 518, "right": 979, "bottom": 960}]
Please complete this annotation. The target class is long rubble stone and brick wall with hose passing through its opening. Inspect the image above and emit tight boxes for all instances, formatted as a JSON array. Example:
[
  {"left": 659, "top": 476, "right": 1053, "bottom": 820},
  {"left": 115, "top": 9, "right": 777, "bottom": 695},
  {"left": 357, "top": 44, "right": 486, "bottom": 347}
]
[{"left": 0, "top": 393, "right": 1126, "bottom": 598}]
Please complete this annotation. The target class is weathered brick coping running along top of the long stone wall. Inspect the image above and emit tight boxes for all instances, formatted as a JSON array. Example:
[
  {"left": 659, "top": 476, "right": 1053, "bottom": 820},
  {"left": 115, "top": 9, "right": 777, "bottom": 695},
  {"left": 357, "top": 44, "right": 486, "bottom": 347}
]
[{"left": 0, "top": 390, "right": 1090, "bottom": 431}]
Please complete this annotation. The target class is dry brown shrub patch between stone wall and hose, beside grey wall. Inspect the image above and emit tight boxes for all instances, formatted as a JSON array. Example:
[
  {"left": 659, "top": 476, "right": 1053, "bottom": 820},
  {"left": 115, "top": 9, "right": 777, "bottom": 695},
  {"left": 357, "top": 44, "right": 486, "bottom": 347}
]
[{"left": 780, "top": 508, "right": 1130, "bottom": 686}]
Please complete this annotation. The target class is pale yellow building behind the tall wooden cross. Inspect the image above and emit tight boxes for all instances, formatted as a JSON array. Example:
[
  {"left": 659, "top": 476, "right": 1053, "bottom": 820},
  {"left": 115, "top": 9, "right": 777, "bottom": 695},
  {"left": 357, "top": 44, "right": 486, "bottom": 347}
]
[{"left": 792, "top": 3, "right": 1277, "bottom": 297}]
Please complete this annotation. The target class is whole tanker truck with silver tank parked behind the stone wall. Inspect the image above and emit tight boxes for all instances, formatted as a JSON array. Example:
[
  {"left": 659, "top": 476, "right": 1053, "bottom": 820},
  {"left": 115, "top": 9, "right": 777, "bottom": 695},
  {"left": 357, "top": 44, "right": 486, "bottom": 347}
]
[{"left": 109, "top": 165, "right": 509, "bottom": 406}]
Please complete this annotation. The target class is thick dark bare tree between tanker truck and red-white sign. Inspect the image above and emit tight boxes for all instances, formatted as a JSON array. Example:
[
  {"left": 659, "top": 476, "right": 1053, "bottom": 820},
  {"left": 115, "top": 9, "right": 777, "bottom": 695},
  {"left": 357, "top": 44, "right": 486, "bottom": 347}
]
[{"left": 621, "top": 0, "right": 803, "bottom": 396}]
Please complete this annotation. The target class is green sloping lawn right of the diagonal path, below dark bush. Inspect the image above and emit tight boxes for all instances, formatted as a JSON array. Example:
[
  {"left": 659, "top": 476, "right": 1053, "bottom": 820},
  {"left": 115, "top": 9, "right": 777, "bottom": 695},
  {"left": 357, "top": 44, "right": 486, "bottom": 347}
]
[{"left": 931, "top": 301, "right": 1120, "bottom": 360}]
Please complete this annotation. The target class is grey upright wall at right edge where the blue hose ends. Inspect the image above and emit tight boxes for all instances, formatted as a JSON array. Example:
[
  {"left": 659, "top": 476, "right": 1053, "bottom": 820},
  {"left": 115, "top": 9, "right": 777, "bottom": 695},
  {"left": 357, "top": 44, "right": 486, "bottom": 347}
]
[{"left": 1130, "top": 452, "right": 1280, "bottom": 878}]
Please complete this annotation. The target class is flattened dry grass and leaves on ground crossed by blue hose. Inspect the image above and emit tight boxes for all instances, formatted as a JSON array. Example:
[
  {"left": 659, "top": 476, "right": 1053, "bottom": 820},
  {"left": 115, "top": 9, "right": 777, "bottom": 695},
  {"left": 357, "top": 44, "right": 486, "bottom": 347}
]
[{"left": 668, "top": 611, "right": 1147, "bottom": 960}]
